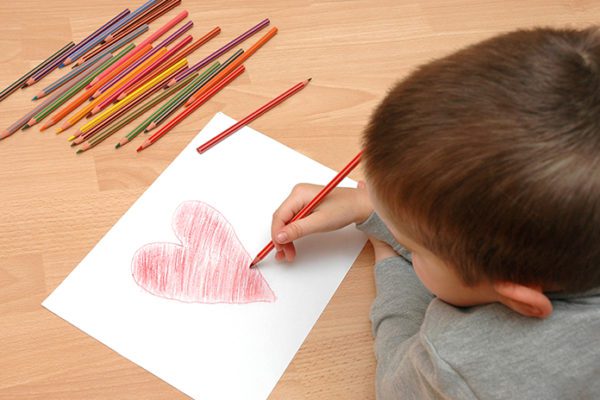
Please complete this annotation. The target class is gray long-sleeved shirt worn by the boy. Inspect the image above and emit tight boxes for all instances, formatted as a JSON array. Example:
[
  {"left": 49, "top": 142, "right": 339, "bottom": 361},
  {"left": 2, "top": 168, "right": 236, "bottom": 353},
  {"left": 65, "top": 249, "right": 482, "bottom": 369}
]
[{"left": 357, "top": 214, "right": 600, "bottom": 400}]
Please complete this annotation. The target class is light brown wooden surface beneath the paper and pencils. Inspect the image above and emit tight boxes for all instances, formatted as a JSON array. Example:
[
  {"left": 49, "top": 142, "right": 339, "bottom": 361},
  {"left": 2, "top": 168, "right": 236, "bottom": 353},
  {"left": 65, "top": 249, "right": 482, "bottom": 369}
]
[{"left": 0, "top": 0, "right": 600, "bottom": 400}]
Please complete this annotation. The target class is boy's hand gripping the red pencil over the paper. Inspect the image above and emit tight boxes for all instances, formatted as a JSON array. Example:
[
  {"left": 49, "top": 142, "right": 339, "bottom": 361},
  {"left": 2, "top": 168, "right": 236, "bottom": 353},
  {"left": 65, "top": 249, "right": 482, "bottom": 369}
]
[{"left": 271, "top": 183, "right": 373, "bottom": 261}]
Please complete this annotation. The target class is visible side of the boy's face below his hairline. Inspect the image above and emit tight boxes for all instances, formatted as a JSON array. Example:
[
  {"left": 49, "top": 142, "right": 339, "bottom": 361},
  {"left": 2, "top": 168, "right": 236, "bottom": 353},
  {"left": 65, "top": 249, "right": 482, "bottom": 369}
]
[{"left": 369, "top": 191, "right": 498, "bottom": 307}]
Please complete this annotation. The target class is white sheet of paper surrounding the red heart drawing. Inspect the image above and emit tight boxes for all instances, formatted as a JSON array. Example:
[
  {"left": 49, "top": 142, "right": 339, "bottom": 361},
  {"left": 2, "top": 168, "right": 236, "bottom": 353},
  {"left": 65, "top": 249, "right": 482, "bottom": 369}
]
[{"left": 42, "top": 113, "right": 366, "bottom": 399}]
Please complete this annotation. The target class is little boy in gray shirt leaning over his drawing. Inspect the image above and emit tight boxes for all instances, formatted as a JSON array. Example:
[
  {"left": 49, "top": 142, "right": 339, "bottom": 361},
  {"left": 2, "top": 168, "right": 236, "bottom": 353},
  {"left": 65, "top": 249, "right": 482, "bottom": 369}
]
[{"left": 272, "top": 28, "right": 600, "bottom": 399}]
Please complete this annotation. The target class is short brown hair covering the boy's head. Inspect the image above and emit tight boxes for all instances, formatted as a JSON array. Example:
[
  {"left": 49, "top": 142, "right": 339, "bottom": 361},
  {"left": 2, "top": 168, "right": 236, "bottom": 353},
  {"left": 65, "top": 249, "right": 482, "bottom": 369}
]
[{"left": 364, "top": 28, "right": 600, "bottom": 315}]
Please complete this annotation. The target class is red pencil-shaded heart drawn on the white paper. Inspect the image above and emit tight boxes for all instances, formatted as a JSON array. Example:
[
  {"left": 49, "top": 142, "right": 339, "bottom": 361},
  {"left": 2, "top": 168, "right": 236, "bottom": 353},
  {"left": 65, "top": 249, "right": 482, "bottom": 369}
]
[{"left": 132, "top": 201, "right": 275, "bottom": 304}]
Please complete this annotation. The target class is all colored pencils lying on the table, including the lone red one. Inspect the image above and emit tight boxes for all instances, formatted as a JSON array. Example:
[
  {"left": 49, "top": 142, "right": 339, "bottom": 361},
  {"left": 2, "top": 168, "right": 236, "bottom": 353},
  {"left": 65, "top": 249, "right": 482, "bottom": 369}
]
[{"left": 0, "top": 0, "right": 308, "bottom": 153}]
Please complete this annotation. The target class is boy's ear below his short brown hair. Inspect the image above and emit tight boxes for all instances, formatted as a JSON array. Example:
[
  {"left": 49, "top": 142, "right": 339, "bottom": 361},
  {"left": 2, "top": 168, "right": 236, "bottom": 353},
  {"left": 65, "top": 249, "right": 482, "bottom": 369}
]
[{"left": 493, "top": 282, "right": 552, "bottom": 318}]
